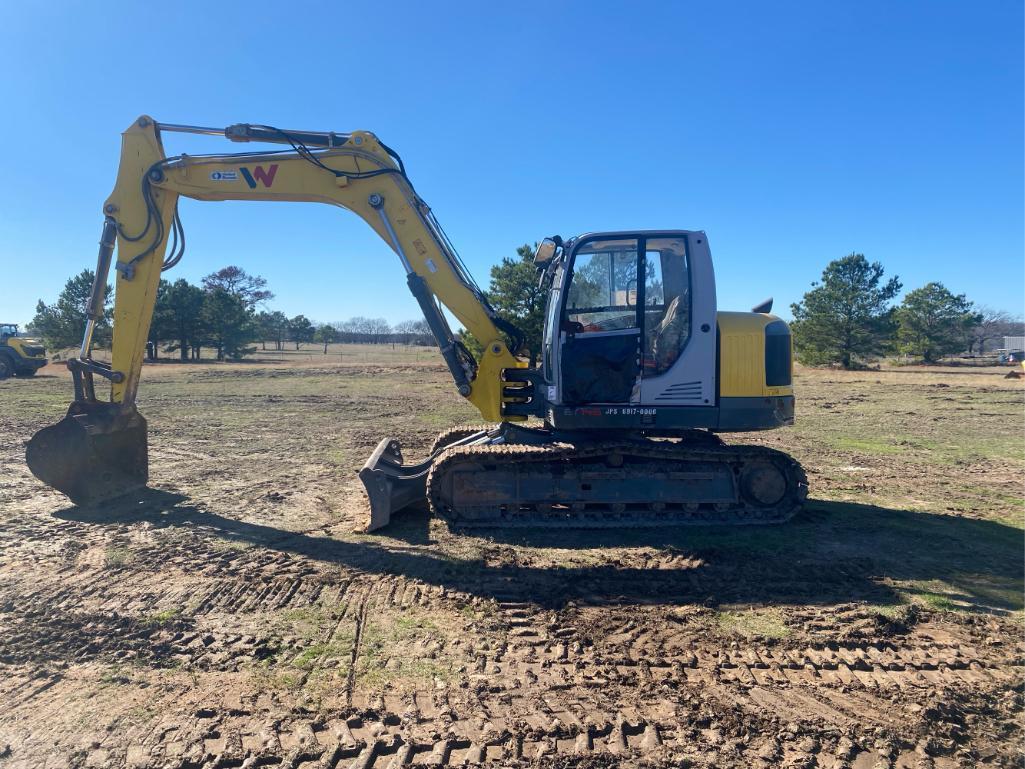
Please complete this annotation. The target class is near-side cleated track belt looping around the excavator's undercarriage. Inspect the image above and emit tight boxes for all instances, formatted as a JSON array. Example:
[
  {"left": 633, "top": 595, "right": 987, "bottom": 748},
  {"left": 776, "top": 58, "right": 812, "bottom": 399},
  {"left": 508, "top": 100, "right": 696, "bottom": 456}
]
[{"left": 427, "top": 441, "right": 808, "bottom": 528}]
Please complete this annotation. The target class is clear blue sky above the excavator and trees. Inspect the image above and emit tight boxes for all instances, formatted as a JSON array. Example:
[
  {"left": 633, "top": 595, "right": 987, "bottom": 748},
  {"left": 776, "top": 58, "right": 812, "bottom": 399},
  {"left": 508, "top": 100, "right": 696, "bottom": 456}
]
[{"left": 0, "top": 0, "right": 1025, "bottom": 323}]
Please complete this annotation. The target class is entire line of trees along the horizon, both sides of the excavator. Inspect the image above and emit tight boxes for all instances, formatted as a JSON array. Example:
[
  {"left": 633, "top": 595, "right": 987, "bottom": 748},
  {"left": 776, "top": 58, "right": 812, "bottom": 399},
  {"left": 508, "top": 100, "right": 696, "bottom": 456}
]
[{"left": 32, "top": 250, "right": 1025, "bottom": 368}]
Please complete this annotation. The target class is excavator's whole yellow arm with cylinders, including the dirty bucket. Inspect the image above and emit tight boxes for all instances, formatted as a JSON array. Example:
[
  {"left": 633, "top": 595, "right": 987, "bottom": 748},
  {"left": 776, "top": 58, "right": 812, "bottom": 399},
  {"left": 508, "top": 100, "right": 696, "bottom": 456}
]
[{"left": 27, "top": 116, "right": 528, "bottom": 518}]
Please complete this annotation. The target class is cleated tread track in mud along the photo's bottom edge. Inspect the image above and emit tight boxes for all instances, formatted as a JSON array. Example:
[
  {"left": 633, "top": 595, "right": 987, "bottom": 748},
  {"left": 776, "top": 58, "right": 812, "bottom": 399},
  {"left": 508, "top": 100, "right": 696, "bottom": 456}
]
[{"left": 49, "top": 709, "right": 1000, "bottom": 769}]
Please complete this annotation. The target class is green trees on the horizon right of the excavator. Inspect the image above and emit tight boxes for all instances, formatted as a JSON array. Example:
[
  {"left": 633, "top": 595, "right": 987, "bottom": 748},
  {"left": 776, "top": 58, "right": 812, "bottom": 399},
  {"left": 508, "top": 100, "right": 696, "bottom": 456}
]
[{"left": 790, "top": 253, "right": 1022, "bottom": 368}]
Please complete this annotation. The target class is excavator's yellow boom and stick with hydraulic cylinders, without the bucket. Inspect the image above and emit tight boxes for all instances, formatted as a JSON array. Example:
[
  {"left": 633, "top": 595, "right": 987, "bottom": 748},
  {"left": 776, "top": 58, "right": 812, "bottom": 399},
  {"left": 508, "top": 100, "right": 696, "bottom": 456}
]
[{"left": 100, "top": 117, "right": 523, "bottom": 421}]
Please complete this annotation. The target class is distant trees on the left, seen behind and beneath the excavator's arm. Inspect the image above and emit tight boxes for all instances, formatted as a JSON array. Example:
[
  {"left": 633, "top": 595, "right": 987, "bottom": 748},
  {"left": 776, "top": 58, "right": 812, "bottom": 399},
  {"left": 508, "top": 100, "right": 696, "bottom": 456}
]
[{"left": 31, "top": 266, "right": 435, "bottom": 361}]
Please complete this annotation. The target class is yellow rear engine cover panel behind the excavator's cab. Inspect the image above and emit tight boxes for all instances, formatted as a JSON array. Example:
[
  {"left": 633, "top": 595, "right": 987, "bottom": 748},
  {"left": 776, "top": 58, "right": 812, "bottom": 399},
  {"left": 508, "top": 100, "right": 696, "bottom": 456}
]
[{"left": 718, "top": 313, "right": 793, "bottom": 398}]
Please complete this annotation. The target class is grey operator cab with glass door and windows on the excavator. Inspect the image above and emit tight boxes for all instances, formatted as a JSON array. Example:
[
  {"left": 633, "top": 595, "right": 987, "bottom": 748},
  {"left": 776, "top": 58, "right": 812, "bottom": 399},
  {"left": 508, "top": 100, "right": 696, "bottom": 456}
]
[{"left": 535, "top": 231, "right": 715, "bottom": 418}]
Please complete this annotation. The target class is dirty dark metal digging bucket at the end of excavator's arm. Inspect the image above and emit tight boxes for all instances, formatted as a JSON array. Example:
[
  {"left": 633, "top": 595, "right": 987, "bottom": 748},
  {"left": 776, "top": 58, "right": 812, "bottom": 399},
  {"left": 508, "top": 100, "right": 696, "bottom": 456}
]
[{"left": 25, "top": 401, "right": 149, "bottom": 507}]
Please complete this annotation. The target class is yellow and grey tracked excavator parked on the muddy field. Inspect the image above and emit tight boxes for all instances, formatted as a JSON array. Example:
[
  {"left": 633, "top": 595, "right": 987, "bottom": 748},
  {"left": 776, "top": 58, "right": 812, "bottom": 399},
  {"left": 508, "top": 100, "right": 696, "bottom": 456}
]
[{"left": 27, "top": 116, "right": 808, "bottom": 530}]
